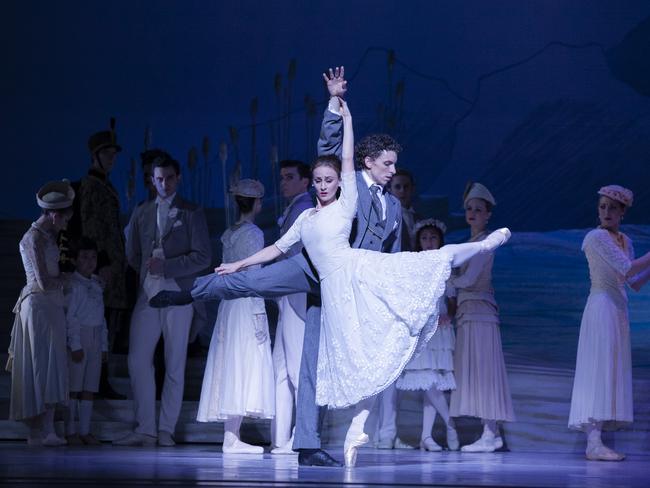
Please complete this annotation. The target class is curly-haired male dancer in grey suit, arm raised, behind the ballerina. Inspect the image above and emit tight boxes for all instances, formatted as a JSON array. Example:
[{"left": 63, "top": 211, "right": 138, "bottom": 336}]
[{"left": 150, "top": 68, "right": 402, "bottom": 466}]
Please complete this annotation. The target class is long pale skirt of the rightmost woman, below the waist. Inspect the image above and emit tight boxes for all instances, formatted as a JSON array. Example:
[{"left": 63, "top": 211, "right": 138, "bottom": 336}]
[{"left": 569, "top": 292, "right": 633, "bottom": 430}]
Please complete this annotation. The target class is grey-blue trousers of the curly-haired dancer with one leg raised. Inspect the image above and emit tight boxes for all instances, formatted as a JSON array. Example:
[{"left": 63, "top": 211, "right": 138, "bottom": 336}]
[{"left": 192, "top": 260, "right": 324, "bottom": 449}]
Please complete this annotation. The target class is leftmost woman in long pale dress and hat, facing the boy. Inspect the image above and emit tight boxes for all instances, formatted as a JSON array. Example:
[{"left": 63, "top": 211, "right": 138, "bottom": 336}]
[{"left": 8, "top": 180, "right": 74, "bottom": 446}]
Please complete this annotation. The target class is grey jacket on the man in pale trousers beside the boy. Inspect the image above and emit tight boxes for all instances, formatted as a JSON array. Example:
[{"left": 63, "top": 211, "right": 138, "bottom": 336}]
[{"left": 126, "top": 195, "right": 211, "bottom": 290}]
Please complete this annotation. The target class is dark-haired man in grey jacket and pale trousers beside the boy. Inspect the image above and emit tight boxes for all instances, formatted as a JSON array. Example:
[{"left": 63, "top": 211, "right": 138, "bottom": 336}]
[{"left": 114, "top": 156, "right": 211, "bottom": 446}]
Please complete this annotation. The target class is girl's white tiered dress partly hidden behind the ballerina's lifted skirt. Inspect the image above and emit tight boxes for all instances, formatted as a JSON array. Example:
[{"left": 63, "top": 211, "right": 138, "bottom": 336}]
[{"left": 395, "top": 288, "right": 456, "bottom": 391}]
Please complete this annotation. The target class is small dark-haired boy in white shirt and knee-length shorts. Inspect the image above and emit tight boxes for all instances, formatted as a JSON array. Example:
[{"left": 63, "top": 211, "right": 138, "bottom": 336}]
[{"left": 66, "top": 237, "right": 108, "bottom": 445}]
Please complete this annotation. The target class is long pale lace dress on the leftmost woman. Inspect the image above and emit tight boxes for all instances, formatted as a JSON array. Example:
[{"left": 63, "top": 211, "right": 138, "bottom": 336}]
[{"left": 9, "top": 222, "right": 68, "bottom": 420}]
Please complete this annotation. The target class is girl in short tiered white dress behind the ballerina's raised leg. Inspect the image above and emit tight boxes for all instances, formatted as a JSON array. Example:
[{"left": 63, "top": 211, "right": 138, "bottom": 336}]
[{"left": 396, "top": 219, "right": 459, "bottom": 451}]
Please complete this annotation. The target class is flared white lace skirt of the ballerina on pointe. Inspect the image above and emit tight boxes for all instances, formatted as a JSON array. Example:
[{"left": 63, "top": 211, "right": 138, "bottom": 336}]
[{"left": 316, "top": 249, "right": 452, "bottom": 408}]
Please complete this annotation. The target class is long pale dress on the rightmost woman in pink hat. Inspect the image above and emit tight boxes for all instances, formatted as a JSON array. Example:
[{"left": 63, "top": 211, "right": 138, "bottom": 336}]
[{"left": 569, "top": 229, "right": 634, "bottom": 429}]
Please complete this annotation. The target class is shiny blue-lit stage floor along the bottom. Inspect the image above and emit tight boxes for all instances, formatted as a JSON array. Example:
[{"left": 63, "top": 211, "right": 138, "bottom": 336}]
[{"left": 0, "top": 442, "right": 650, "bottom": 487}]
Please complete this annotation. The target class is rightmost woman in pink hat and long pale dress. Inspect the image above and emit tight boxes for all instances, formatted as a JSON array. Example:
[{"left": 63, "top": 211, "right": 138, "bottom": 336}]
[{"left": 569, "top": 185, "right": 650, "bottom": 461}]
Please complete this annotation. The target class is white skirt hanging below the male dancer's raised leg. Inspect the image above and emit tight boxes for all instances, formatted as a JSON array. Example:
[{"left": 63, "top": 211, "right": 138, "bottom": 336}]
[{"left": 197, "top": 298, "right": 275, "bottom": 422}]
